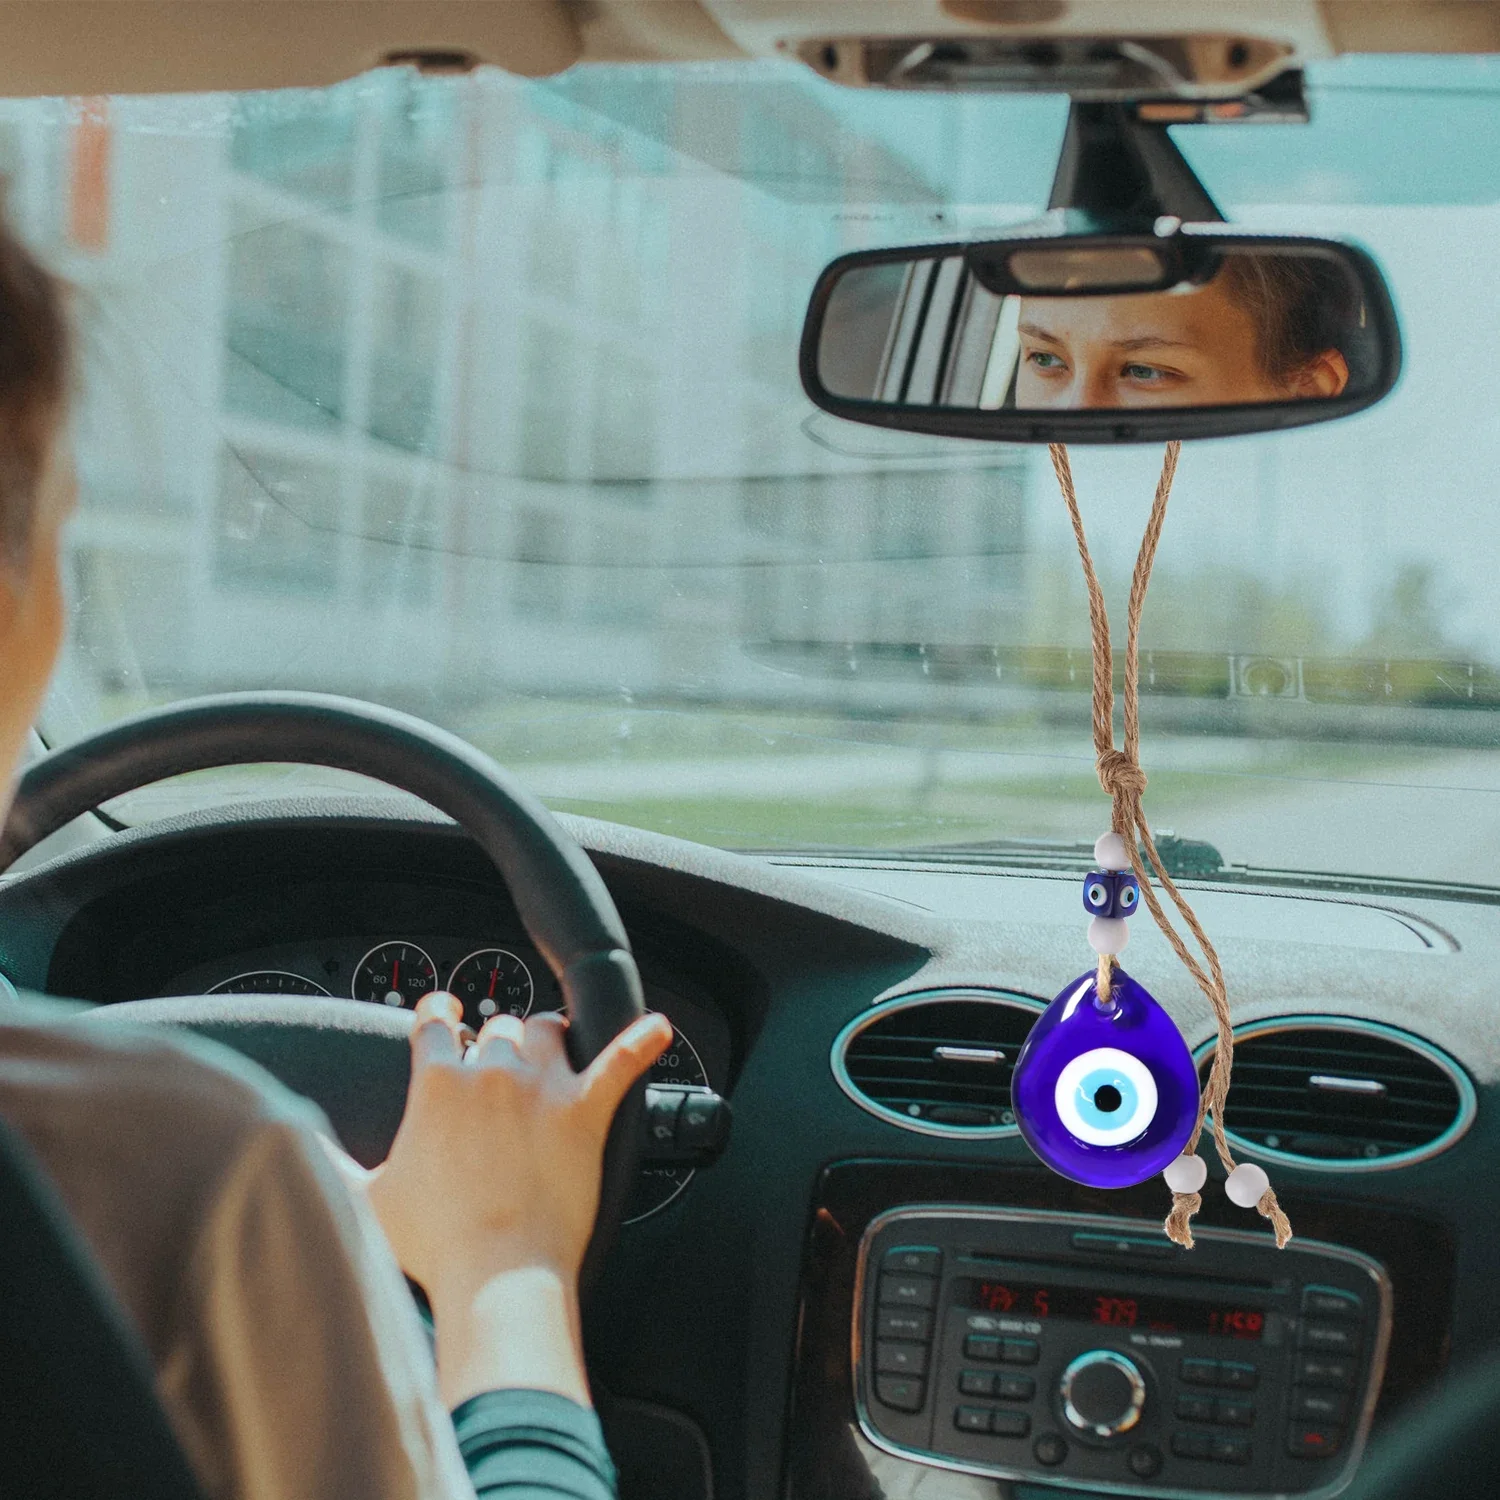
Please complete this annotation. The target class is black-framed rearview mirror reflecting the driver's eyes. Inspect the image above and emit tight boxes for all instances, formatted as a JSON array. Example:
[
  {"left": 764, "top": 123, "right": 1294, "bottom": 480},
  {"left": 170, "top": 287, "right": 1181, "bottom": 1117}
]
[{"left": 801, "top": 230, "right": 1401, "bottom": 443}]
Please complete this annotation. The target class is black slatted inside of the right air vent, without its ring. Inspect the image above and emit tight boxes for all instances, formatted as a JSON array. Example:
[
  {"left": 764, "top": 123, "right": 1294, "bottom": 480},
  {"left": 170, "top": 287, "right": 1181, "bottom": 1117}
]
[{"left": 1202, "top": 1028, "right": 1461, "bottom": 1164}]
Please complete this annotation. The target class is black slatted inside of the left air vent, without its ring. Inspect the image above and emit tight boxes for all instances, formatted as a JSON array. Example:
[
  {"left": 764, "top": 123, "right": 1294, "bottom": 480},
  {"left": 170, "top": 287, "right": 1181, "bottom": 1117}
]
[{"left": 843, "top": 998, "right": 1038, "bottom": 1133}]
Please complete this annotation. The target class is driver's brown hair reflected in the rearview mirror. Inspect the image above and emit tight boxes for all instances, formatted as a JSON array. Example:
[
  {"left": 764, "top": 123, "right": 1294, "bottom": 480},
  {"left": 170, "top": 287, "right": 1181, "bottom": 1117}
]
[{"left": 1221, "top": 255, "right": 1356, "bottom": 384}]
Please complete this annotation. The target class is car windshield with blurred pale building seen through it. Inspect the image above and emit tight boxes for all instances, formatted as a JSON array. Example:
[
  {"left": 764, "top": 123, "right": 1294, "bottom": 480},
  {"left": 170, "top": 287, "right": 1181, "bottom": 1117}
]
[{"left": 17, "top": 59, "right": 1500, "bottom": 884}]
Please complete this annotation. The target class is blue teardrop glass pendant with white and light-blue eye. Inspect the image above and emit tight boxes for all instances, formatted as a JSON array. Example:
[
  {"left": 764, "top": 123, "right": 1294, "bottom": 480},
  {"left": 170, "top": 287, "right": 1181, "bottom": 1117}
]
[{"left": 1011, "top": 969, "right": 1199, "bottom": 1188}]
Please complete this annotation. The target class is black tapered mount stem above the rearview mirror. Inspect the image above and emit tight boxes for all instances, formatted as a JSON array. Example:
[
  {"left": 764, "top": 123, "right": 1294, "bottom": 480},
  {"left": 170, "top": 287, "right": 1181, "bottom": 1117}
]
[{"left": 1047, "top": 99, "right": 1224, "bottom": 233}]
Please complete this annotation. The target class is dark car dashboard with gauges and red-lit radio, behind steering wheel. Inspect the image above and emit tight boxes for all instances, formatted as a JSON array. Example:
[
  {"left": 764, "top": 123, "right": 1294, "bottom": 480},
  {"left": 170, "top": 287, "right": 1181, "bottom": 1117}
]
[{"left": 0, "top": 798, "right": 1500, "bottom": 1500}]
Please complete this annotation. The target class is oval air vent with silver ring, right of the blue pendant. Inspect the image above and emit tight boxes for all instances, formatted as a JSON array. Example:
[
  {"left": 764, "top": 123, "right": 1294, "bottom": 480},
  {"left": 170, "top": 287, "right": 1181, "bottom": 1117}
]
[{"left": 1197, "top": 1016, "right": 1475, "bottom": 1172}]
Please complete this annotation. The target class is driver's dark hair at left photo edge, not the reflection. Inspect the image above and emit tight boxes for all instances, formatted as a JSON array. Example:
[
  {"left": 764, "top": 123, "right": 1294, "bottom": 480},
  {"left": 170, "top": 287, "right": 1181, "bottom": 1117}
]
[{"left": 0, "top": 216, "right": 72, "bottom": 566}]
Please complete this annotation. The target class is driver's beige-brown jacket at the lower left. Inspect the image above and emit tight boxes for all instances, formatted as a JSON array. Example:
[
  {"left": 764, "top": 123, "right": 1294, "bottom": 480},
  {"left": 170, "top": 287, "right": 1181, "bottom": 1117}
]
[{"left": 0, "top": 1020, "right": 474, "bottom": 1500}]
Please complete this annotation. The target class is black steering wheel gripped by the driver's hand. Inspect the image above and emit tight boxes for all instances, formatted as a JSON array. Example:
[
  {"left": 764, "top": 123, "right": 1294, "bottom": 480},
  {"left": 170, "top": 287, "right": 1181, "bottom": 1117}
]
[{"left": 0, "top": 693, "right": 645, "bottom": 1283}]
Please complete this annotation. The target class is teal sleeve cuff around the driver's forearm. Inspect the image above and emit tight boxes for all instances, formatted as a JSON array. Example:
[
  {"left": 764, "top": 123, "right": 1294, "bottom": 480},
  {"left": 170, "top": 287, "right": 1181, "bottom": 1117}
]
[{"left": 453, "top": 1391, "right": 618, "bottom": 1500}]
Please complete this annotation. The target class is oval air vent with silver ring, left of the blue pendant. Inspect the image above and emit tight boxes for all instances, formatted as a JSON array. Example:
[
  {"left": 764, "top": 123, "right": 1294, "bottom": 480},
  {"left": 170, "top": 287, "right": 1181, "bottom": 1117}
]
[{"left": 833, "top": 990, "right": 1043, "bottom": 1140}]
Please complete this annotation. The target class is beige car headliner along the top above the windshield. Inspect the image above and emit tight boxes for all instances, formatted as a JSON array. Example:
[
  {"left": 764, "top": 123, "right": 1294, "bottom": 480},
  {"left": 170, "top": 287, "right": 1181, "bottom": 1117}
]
[{"left": 0, "top": 0, "right": 1500, "bottom": 96}]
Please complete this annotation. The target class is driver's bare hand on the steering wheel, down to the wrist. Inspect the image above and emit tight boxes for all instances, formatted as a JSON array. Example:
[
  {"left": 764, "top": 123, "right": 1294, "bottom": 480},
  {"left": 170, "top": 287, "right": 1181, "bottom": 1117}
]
[{"left": 368, "top": 995, "right": 672, "bottom": 1308}]
